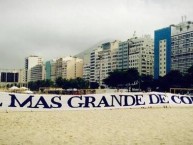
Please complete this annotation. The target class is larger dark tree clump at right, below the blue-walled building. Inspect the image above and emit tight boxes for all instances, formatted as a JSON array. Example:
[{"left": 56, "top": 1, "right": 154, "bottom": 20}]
[{"left": 104, "top": 66, "right": 193, "bottom": 92}]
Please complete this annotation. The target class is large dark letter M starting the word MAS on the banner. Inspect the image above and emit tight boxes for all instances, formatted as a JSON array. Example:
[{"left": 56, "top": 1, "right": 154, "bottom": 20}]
[{"left": 9, "top": 94, "right": 34, "bottom": 107}]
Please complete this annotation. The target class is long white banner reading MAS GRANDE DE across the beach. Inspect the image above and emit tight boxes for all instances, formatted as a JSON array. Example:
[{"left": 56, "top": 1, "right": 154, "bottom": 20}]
[{"left": 0, "top": 92, "right": 193, "bottom": 111}]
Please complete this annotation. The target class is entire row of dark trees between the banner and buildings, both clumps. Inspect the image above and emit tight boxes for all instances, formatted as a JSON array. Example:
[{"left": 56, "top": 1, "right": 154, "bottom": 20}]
[{"left": 28, "top": 66, "right": 193, "bottom": 92}]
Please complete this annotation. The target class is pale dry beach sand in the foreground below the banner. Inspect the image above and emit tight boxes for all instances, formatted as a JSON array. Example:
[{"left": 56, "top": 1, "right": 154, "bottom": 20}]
[{"left": 0, "top": 108, "right": 193, "bottom": 145}]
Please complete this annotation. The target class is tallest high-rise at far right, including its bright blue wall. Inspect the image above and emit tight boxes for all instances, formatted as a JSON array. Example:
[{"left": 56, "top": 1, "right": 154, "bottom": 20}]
[{"left": 154, "top": 21, "right": 193, "bottom": 79}]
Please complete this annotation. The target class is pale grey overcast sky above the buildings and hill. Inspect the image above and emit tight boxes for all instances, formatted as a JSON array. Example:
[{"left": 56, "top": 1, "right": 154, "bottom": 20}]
[{"left": 0, "top": 0, "right": 193, "bottom": 69}]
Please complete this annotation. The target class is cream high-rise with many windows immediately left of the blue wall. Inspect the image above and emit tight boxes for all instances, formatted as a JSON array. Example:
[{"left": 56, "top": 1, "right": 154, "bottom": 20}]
[{"left": 128, "top": 35, "right": 154, "bottom": 76}]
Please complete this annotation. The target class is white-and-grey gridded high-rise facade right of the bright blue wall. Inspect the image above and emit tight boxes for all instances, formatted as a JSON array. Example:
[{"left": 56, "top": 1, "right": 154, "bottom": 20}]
[{"left": 171, "top": 21, "right": 193, "bottom": 73}]
